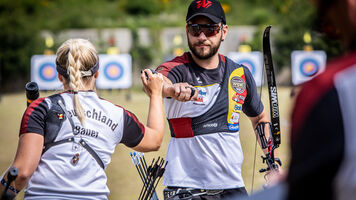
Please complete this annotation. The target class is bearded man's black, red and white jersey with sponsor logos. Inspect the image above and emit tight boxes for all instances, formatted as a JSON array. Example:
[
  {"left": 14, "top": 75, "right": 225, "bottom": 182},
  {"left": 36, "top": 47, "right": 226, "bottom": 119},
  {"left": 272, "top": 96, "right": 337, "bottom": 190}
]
[{"left": 156, "top": 53, "right": 263, "bottom": 189}]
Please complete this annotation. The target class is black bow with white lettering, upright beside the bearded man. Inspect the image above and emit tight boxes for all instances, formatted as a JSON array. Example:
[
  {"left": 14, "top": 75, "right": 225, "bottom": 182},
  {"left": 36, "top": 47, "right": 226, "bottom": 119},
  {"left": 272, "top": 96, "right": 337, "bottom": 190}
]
[{"left": 256, "top": 26, "right": 282, "bottom": 188}]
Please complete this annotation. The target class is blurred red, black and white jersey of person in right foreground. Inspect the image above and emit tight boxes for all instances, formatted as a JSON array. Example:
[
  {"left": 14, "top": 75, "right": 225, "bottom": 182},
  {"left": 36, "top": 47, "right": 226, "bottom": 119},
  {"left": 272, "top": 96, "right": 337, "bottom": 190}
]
[{"left": 288, "top": 52, "right": 356, "bottom": 199}]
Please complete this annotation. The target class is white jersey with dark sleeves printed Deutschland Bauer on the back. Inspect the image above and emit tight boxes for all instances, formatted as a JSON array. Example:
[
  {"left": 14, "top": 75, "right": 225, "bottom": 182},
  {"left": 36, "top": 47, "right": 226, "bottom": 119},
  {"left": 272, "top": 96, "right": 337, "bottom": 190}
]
[{"left": 20, "top": 91, "right": 145, "bottom": 199}]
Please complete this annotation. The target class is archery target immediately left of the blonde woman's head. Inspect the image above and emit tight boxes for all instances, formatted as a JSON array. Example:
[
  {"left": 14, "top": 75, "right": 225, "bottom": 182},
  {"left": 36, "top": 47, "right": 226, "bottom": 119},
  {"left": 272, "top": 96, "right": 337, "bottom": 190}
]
[{"left": 31, "top": 55, "right": 62, "bottom": 90}]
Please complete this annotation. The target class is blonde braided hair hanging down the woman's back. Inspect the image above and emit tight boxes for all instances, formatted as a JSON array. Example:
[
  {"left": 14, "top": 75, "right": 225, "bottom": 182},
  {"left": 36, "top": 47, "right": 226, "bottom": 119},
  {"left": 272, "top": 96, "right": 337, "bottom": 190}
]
[{"left": 57, "top": 39, "right": 98, "bottom": 126}]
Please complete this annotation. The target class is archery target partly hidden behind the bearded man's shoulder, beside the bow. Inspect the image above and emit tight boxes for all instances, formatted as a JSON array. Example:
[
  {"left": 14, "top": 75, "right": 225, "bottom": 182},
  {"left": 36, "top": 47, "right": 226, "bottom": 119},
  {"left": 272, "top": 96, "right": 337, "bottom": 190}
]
[{"left": 227, "top": 51, "right": 263, "bottom": 87}]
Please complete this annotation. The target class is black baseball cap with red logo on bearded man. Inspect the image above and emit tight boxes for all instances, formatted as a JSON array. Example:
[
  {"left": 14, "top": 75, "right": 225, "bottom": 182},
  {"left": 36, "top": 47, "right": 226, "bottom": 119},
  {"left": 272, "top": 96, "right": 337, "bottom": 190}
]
[{"left": 185, "top": 0, "right": 226, "bottom": 24}]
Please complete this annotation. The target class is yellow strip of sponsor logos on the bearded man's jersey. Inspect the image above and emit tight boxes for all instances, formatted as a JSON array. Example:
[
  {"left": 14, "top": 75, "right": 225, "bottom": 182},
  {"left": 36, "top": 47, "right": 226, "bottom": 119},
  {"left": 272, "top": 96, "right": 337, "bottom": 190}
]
[{"left": 227, "top": 67, "right": 247, "bottom": 131}]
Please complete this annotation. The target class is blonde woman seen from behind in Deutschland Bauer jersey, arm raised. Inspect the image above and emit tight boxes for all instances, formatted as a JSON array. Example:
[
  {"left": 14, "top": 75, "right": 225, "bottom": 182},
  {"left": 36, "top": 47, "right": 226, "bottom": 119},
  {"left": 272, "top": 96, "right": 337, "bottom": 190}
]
[{"left": 0, "top": 39, "right": 164, "bottom": 200}]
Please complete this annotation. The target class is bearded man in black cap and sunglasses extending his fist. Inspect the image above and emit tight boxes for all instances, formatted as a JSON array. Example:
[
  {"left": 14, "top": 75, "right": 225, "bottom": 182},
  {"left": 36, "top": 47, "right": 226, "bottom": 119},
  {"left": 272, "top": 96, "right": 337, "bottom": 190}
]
[{"left": 156, "top": 0, "right": 280, "bottom": 199}]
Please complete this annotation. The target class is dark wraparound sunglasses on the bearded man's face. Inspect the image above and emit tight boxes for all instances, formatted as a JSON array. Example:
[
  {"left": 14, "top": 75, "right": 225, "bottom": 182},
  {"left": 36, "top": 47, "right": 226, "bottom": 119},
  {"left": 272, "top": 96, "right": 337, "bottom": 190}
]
[{"left": 187, "top": 24, "right": 224, "bottom": 37}]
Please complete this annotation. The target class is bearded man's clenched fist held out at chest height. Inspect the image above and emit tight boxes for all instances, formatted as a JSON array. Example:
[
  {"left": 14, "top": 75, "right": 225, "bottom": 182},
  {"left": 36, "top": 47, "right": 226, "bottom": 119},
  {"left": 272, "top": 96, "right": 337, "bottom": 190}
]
[{"left": 164, "top": 83, "right": 199, "bottom": 102}]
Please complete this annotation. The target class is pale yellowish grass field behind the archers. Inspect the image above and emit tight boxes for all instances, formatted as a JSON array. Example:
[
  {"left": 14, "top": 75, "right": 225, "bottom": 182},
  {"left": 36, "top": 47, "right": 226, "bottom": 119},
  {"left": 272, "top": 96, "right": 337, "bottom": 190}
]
[{"left": 0, "top": 88, "right": 292, "bottom": 199}]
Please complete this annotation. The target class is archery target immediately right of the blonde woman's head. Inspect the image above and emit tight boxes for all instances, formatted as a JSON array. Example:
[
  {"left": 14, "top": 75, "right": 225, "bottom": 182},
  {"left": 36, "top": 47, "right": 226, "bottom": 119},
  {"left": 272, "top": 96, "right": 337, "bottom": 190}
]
[{"left": 96, "top": 54, "right": 132, "bottom": 89}]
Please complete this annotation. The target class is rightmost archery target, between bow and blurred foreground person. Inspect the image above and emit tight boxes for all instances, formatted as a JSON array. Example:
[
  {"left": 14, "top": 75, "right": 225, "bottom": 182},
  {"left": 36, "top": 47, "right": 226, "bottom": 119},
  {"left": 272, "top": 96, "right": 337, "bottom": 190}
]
[{"left": 291, "top": 51, "right": 326, "bottom": 85}]
